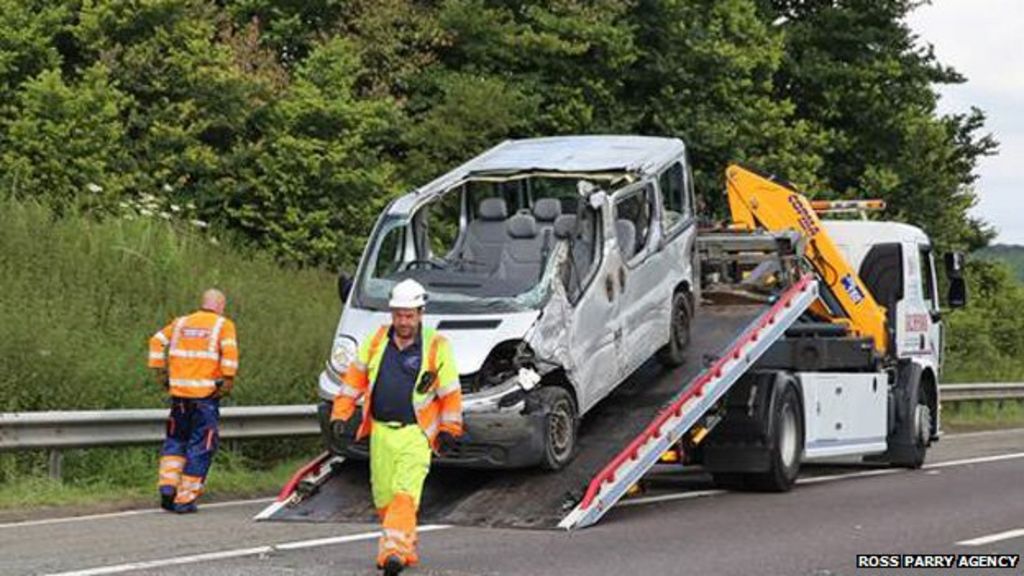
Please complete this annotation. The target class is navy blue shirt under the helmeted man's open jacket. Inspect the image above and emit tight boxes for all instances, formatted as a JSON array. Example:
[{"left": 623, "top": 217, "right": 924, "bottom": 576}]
[{"left": 370, "top": 328, "right": 423, "bottom": 424}]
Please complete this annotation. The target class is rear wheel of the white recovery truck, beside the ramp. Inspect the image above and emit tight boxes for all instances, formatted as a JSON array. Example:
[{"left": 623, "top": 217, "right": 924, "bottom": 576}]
[{"left": 746, "top": 384, "right": 804, "bottom": 492}]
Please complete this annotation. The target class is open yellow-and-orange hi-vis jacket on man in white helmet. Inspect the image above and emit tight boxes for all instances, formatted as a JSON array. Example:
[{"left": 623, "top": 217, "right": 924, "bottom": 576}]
[{"left": 331, "top": 326, "right": 462, "bottom": 449}]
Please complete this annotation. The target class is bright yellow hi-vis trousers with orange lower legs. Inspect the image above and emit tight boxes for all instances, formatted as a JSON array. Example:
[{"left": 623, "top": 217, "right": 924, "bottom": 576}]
[{"left": 370, "top": 421, "right": 430, "bottom": 566}]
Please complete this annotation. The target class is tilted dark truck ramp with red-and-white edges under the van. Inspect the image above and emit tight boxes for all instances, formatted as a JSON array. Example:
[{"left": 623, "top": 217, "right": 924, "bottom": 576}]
[{"left": 256, "top": 277, "right": 817, "bottom": 529}]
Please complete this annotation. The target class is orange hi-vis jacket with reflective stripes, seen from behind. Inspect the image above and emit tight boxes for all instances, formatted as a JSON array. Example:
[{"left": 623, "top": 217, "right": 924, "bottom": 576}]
[{"left": 150, "top": 311, "right": 239, "bottom": 398}]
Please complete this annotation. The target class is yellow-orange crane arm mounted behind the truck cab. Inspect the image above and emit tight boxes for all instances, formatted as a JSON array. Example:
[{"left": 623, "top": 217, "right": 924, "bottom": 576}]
[{"left": 725, "top": 164, "right": 889, "bottom": 354}]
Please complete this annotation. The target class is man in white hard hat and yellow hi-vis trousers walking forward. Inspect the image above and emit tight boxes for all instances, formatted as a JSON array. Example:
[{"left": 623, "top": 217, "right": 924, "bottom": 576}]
[{"left": 331, "top": 280, "right": 462, "bottom": 575}]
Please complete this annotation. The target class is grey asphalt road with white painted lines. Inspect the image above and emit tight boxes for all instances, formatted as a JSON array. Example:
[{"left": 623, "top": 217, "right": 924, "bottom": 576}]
[{"left": 0, "top": 430, "right": 1024, "bottom": 576}]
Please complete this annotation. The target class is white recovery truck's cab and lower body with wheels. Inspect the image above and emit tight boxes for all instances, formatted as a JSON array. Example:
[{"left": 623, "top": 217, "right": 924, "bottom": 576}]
[{"left": 690, "top": 177, "right": 966, "bottom": 490}]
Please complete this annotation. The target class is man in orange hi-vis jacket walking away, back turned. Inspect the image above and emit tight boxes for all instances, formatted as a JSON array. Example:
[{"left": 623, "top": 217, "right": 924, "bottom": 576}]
[{"left": 150, "top": 289, "right": 239, "bottom": 513}]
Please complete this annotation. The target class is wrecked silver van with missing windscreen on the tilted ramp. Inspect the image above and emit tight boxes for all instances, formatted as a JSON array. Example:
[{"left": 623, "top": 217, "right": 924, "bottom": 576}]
[{"left": 319, "top": 136, "right": 697, "bottom": 469}]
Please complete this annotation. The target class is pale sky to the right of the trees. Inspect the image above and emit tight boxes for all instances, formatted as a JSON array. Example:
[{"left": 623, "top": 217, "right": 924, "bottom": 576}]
[{"left": 907, "top": 0, "right": 1024, "bottom": 245}]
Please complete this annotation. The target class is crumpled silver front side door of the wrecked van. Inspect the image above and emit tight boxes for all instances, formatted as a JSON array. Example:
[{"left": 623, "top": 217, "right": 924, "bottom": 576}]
[{"left": 564, "top": 201, "right": 623, "bottom": 413}]
